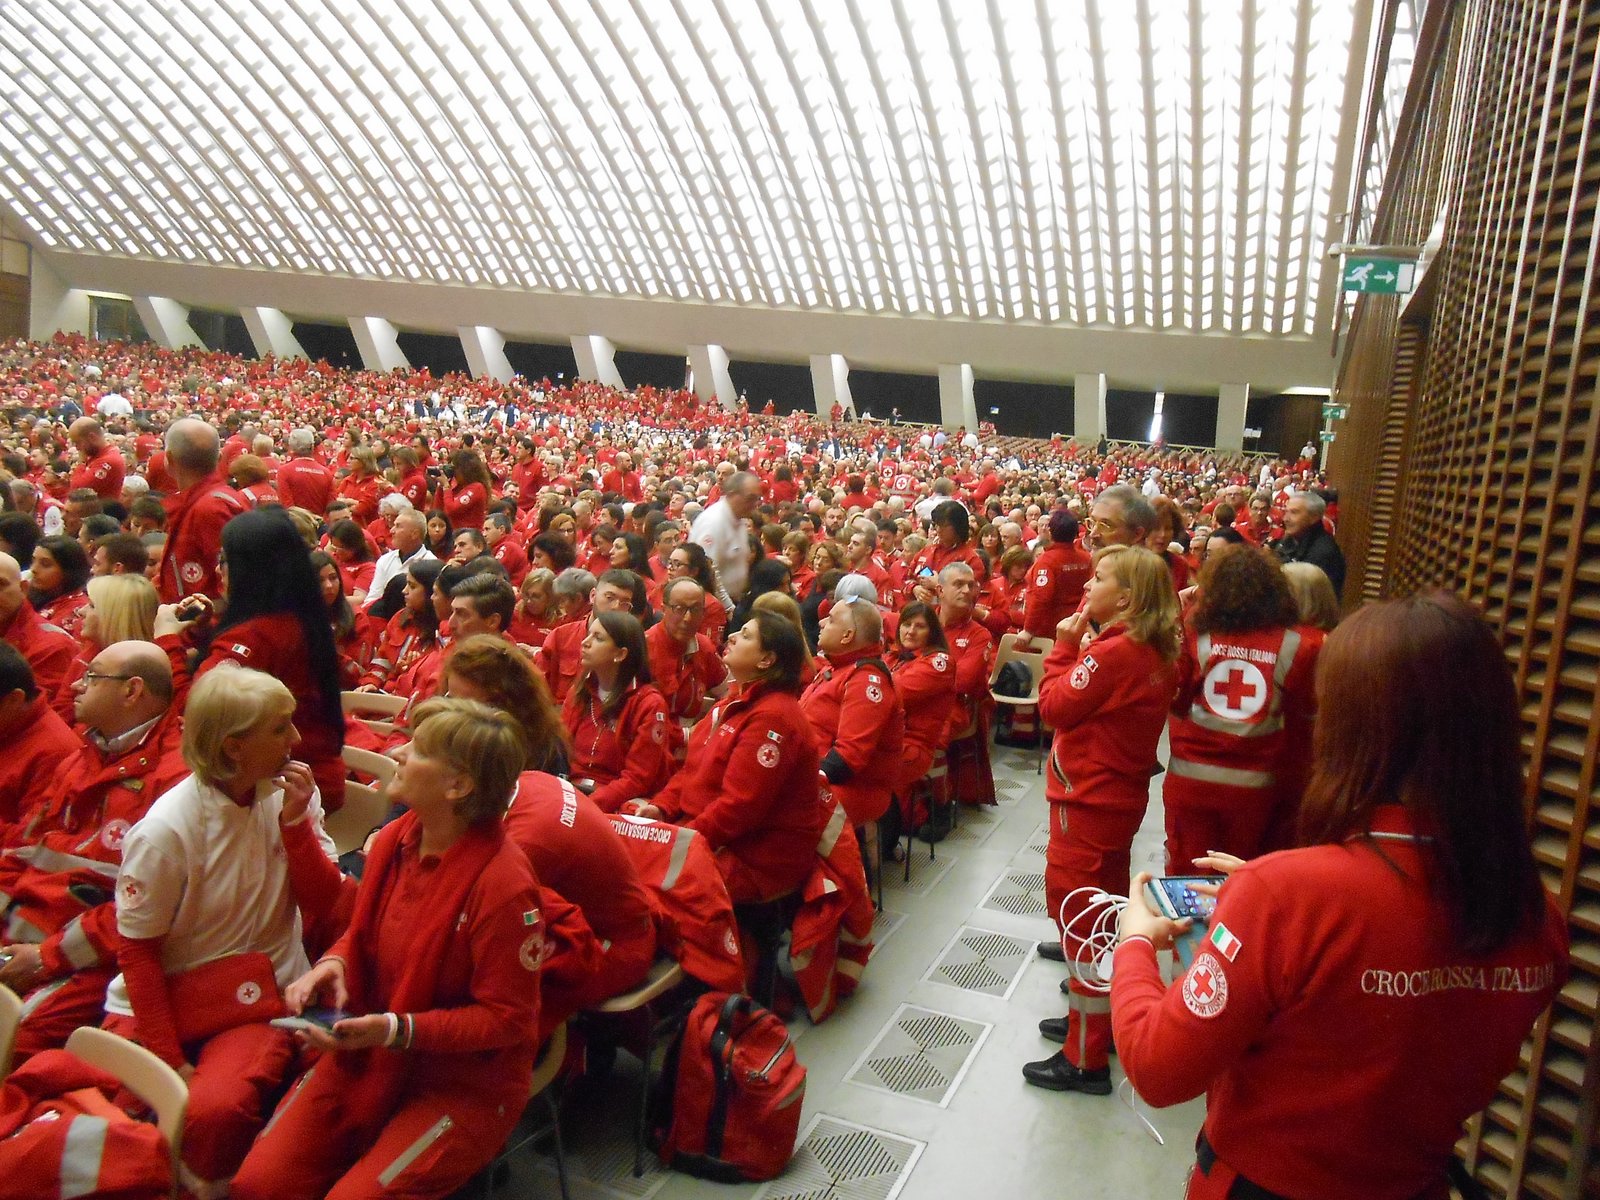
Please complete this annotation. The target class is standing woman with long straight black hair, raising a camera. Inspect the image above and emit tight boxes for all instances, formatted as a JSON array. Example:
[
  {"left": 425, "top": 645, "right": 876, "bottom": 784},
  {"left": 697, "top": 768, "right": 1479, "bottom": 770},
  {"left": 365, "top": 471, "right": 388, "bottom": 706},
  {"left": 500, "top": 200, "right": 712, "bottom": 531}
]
[{"left": 155, "top": 509, "right": 344, "bottom": 811}]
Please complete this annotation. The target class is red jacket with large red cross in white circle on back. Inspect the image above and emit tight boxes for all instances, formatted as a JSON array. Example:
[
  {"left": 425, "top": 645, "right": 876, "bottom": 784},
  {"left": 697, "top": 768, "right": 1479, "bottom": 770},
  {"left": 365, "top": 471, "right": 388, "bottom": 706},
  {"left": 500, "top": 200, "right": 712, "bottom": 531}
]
[{"left": 1165, "top": 629, "right": 1322, "bottom": 806}]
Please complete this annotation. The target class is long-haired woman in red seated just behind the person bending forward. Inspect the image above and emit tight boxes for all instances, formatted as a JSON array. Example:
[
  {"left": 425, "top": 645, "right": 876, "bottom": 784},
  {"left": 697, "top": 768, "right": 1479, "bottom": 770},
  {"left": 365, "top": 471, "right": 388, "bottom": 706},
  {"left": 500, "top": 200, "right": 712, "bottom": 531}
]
[{"left": 562, "top": 613, "right": 682, "bottom": 813}]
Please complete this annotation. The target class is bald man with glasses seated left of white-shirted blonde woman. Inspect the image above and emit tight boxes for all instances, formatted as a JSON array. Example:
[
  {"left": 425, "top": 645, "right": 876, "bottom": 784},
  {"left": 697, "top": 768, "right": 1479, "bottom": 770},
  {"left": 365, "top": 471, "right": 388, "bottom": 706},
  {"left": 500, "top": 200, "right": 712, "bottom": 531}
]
[{"left": 0, "top": 642, "right": 189, "bottom": 1062}]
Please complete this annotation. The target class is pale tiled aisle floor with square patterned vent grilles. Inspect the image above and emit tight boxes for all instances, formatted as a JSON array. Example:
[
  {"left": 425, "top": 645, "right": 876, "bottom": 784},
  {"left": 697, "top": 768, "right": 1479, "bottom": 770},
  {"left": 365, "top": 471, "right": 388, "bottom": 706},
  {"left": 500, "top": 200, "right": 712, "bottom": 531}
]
[{"left": 496, "top": 749, "right": 1203, "bottom": 1200}]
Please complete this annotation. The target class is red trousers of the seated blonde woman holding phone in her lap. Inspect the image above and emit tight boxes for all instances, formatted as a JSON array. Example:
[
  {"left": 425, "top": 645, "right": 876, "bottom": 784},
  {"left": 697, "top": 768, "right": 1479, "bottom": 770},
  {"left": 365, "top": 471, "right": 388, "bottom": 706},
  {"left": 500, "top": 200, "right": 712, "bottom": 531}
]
[{"left": 232, "top": 1051, "right": 523, "bottom": 1200}]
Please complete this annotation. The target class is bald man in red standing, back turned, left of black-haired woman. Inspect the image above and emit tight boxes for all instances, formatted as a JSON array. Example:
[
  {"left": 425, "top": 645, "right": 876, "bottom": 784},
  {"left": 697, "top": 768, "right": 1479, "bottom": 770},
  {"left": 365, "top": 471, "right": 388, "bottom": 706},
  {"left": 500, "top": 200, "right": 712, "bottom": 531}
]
[{"left": 157, "top": 418, "right": 250, "bottom": 605}]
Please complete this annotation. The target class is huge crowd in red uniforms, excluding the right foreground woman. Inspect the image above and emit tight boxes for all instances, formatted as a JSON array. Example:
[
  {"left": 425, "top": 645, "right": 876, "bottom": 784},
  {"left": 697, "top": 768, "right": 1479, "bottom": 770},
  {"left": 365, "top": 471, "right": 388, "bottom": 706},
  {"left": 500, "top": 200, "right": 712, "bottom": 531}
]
[{"left": 0, "top": 336, "right": 1561, "bottom": 1197}]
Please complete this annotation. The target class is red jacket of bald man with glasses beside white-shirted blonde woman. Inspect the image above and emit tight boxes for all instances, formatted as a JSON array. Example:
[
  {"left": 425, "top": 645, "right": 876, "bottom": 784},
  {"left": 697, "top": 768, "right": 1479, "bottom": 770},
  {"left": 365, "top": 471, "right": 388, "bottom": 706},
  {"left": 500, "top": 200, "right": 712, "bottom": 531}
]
[{"left": 0, "top": 706, "right": 189, "bottom": 982}]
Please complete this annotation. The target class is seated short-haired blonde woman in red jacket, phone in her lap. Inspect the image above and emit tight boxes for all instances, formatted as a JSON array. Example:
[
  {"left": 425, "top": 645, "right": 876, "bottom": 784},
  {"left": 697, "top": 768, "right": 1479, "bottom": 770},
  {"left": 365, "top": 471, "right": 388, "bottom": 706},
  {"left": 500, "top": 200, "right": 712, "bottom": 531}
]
[{"left": 230, "top": 698, "right": 544, "bottom": 1200}]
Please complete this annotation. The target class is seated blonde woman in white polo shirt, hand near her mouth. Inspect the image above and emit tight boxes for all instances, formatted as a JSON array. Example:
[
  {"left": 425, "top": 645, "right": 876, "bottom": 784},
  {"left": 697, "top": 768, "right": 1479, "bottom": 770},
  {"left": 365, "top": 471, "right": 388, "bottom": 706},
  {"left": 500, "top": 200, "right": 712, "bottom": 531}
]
[{"left": 106, "top": 662, "right": 341, "bottom": 1195}]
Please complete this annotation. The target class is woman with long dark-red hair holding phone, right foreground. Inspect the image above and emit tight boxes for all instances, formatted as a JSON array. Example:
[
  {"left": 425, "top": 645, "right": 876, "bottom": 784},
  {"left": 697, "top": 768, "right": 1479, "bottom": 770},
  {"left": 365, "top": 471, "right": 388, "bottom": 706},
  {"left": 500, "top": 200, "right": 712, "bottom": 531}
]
[{"left": 1110, "top": 590, "right": 1568, "bottom": 1200}]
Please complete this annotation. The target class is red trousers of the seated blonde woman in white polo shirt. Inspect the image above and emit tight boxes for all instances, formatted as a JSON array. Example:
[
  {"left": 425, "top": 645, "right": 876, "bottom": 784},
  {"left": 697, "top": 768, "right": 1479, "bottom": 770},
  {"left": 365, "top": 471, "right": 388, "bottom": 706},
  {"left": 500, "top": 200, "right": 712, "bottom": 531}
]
[{"left": 106, "top": 1014, "right": 294, "bottom": 1200}]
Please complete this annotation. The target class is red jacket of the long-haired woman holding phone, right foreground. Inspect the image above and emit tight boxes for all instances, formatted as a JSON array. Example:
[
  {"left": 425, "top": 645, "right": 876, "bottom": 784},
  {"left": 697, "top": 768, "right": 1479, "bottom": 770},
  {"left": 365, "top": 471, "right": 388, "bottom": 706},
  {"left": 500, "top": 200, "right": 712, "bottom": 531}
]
[{"left": 1112, "top": 805, "right": 1568, "bottom": 1200}]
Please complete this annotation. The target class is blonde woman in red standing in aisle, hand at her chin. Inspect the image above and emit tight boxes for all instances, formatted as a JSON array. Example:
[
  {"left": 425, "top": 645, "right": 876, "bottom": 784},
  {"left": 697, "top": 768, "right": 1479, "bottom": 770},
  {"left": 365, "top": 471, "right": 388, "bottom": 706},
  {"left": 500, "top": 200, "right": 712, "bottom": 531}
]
[{"left": 1022, "top": 546, "right": 1179, "bottom": 1096}]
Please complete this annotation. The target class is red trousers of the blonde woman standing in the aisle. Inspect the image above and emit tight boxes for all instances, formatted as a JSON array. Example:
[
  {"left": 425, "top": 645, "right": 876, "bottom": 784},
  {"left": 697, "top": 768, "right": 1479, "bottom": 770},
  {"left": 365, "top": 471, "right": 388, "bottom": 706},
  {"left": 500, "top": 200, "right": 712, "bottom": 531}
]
[{"left": 1045, "top": 800, "right": 1146, "bottom": 1070}]
